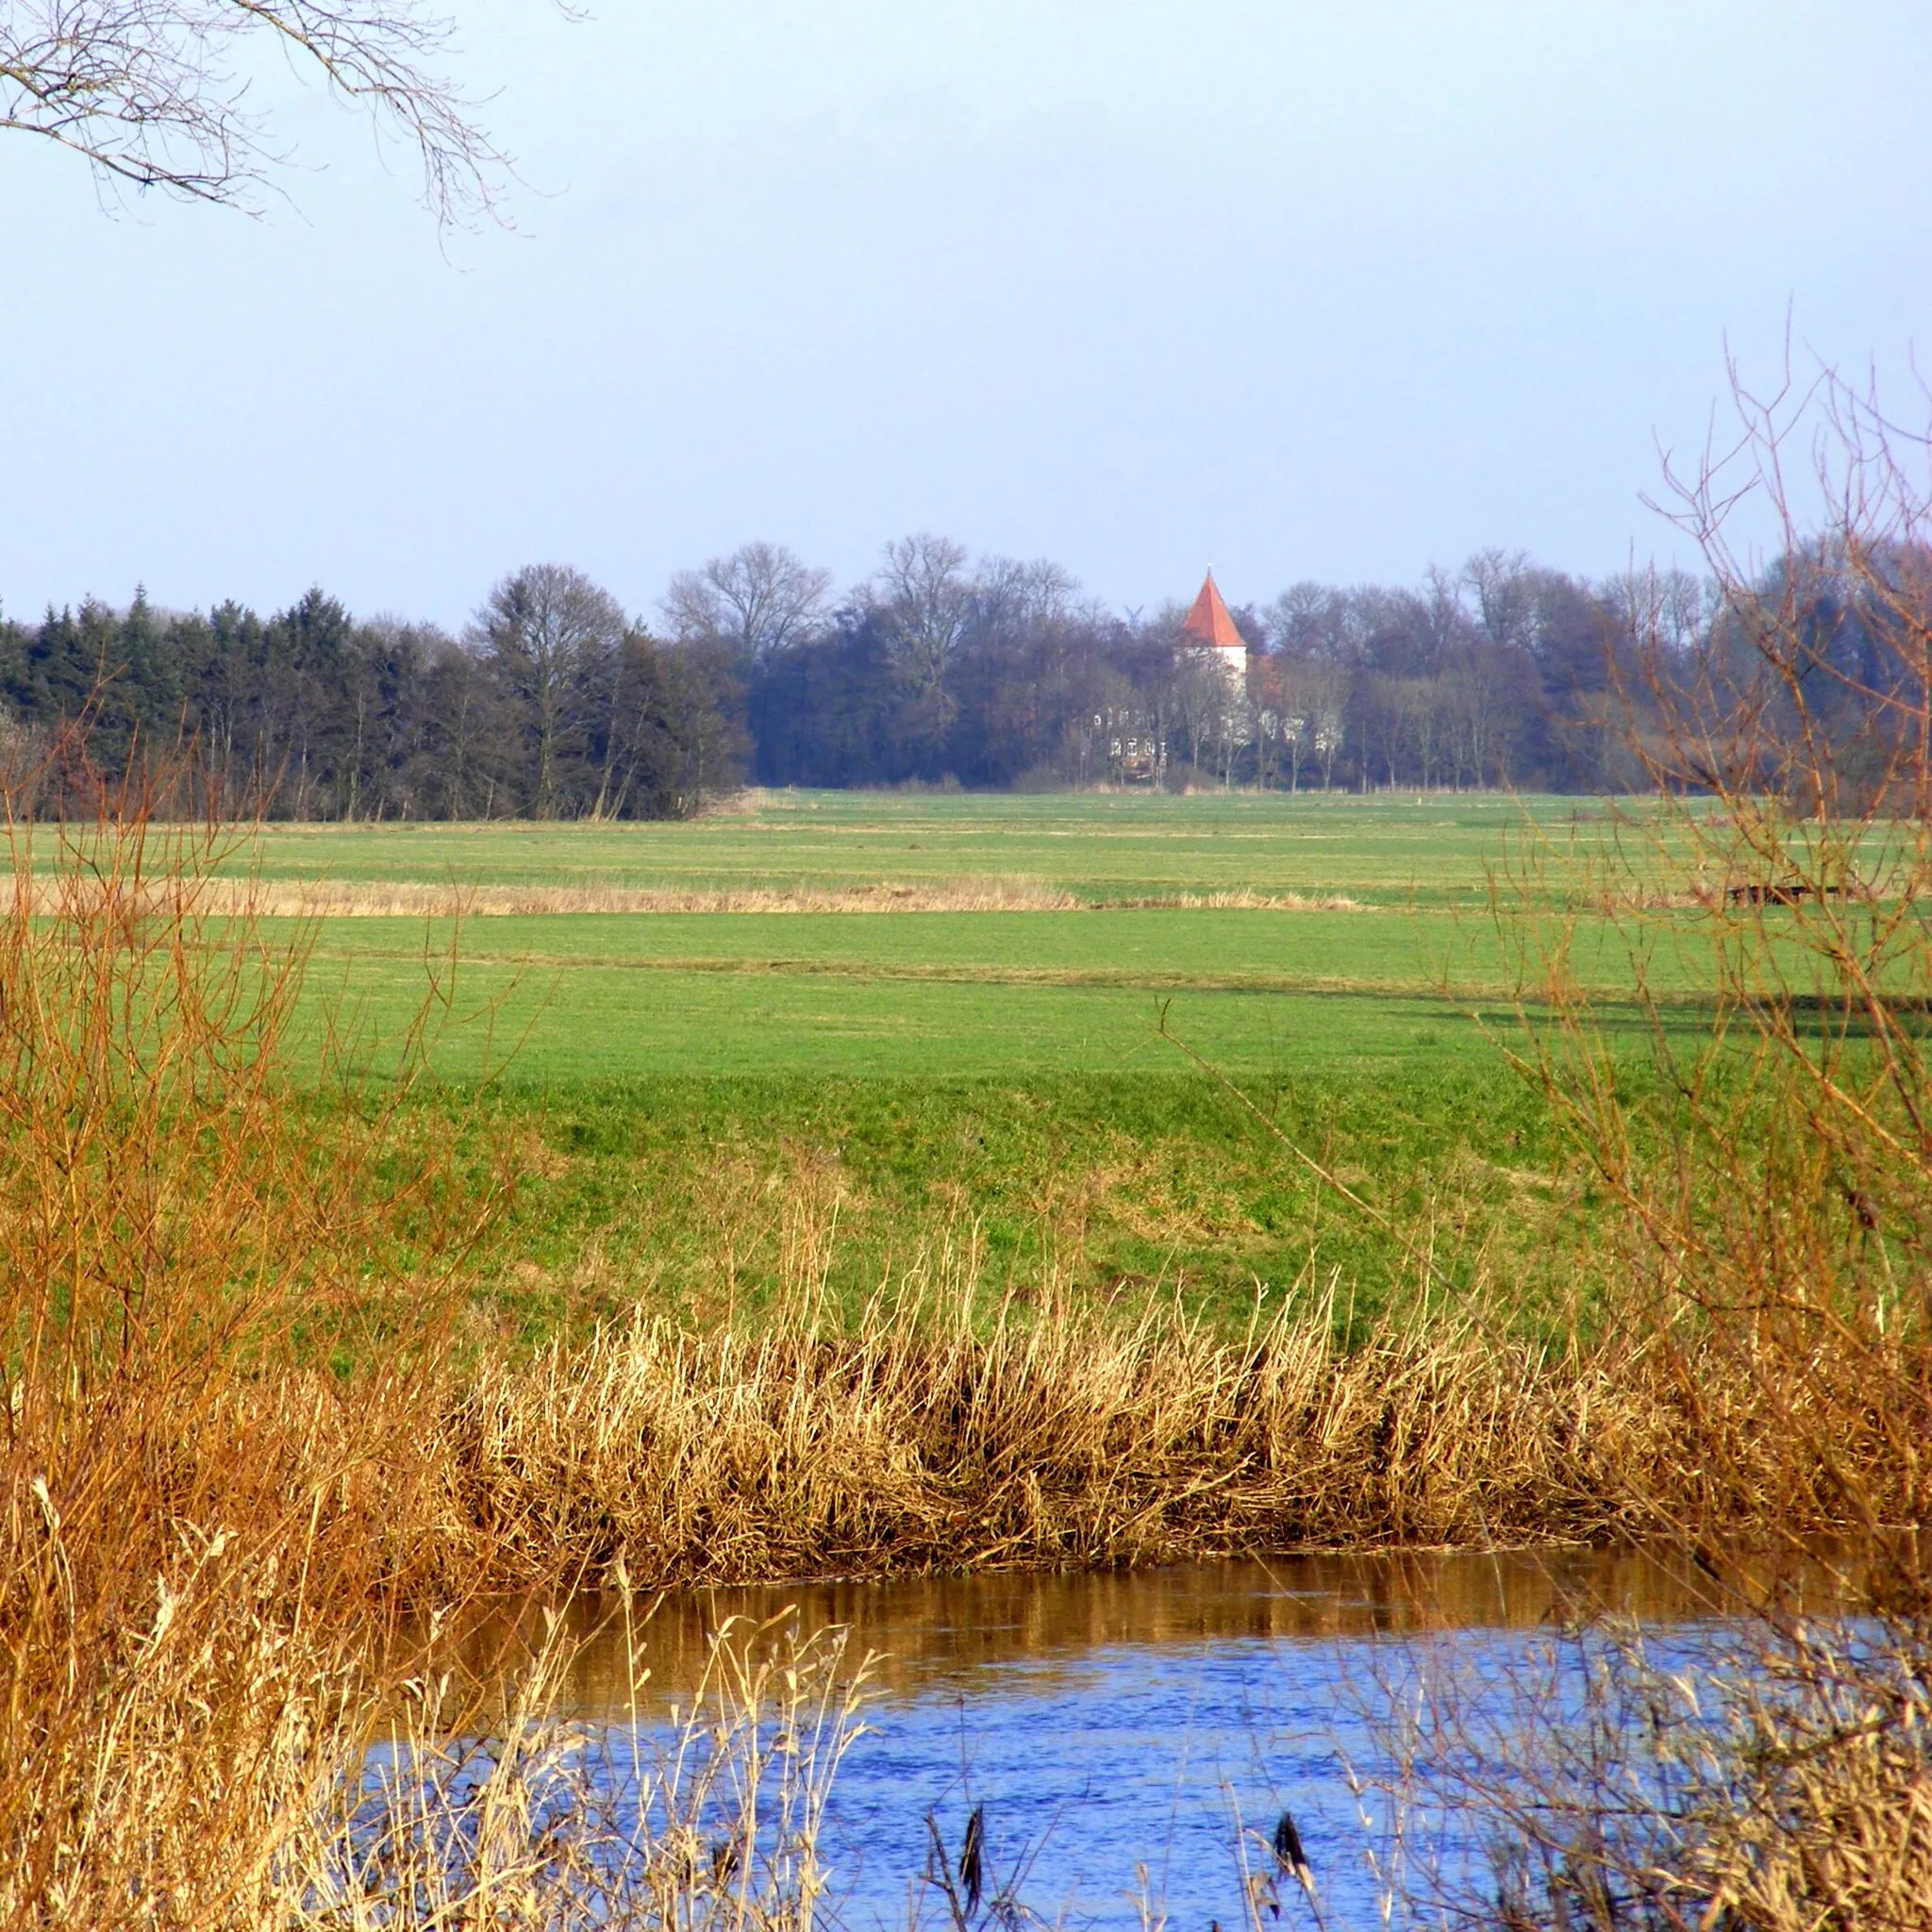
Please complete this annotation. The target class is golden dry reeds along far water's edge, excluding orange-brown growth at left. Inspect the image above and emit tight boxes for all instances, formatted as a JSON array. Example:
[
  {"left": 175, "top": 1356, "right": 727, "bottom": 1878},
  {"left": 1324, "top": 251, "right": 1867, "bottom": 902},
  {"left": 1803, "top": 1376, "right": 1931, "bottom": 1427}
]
[{"left": 435, "top": 1306, "right": 1905, "bottom": 1586}]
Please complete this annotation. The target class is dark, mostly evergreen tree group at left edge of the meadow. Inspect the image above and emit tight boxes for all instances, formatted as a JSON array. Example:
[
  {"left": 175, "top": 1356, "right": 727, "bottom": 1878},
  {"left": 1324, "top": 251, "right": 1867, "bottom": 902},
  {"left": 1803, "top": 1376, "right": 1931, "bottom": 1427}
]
[{"left": 0, "top": 564, "right": 748, "bottom": 819}]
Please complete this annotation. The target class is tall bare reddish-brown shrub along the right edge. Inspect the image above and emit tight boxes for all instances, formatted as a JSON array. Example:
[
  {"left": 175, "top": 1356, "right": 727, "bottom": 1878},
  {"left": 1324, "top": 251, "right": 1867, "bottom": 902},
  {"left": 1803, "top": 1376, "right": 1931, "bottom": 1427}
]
[{"left": 1422, "top": 365, "right": 1932, "bottom": 1932}]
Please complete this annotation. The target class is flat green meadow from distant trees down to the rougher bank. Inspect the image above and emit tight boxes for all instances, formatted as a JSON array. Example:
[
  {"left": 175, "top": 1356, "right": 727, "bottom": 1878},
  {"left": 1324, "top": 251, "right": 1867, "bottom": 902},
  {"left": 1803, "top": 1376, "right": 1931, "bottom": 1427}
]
[{"left": 268, "top": 794, "right": 1690, "bottom": 1086}]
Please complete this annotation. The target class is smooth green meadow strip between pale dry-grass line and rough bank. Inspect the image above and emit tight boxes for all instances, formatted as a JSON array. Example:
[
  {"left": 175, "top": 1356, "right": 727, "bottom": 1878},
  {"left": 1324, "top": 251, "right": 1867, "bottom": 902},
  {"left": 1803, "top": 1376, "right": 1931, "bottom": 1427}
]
[{"left": 313, "top": 912, "right": 1501, "bottom": 1086}]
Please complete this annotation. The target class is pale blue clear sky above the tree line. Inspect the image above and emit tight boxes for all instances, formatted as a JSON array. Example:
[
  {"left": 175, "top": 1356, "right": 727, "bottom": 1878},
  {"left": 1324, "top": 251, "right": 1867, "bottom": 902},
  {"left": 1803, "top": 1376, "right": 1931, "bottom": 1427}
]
[{"left": 0, "top": 0, "right": 1932, "bottom": 628}]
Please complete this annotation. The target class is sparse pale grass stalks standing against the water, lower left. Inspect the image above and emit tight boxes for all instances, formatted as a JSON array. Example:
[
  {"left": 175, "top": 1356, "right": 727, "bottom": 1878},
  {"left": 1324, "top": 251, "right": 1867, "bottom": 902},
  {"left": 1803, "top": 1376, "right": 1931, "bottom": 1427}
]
[{"left": 279, "top": 1615, "right": 872, "bottom": 1932}]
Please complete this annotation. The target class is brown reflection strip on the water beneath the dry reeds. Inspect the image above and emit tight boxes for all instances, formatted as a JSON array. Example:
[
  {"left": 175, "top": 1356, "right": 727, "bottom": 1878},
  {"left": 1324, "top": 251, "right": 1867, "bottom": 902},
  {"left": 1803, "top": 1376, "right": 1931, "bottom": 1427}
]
[{"left": 496, "top": 1549, "right": 1838, "bottom": 1716}]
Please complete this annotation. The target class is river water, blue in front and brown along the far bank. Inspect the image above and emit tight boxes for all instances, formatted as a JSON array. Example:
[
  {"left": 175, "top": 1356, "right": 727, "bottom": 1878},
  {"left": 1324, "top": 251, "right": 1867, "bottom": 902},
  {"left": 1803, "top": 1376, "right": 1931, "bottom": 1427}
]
[{"left": 467, "top": 1549, "right": 1824, "bottom": 1932}]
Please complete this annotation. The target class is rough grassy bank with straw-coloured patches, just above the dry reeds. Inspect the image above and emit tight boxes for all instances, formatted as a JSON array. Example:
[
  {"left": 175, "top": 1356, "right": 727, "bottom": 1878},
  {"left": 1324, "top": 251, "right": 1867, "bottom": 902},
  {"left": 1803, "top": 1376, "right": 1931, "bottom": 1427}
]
[{"left": 434, "top": 1051, "right": 1578, "bottom": 1339}]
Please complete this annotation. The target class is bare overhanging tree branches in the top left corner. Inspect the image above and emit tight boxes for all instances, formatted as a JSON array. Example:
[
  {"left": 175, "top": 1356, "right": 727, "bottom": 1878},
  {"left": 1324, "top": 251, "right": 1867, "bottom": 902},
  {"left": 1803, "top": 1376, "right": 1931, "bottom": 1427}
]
[{"left": 0, "top": 0, "right": 510, "bottom": 223}]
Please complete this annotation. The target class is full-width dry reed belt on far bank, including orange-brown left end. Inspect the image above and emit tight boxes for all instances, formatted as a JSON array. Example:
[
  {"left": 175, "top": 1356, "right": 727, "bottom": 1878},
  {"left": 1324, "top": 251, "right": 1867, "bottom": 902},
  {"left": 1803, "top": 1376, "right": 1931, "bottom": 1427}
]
[{"left": 34, "top": 1304, "right": 1923, "bottom": 1626}]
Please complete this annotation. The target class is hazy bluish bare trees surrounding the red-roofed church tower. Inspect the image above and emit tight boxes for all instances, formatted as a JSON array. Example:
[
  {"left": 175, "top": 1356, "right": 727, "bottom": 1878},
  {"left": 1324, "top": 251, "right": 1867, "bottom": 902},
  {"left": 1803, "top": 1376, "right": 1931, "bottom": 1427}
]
[{"left": 730, "top": 537, "right": 1669, "bottom": 791}]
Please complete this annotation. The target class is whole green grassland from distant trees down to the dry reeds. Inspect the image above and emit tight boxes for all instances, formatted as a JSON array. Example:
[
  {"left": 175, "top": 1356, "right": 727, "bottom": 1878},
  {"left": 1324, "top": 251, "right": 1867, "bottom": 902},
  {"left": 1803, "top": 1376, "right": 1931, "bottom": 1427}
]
[{"left": 234, "top": 794, "right": 1694, "bottom": 1327}]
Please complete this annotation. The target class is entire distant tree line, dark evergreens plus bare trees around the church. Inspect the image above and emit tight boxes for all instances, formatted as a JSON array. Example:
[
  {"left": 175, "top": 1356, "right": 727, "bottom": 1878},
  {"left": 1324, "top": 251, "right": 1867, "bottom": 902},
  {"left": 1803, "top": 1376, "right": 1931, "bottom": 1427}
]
[{"left": 0, "top": 535, "right": 1807, "bottom": 819}]
